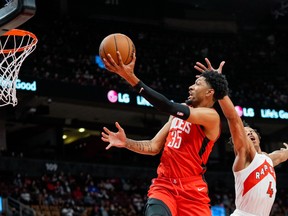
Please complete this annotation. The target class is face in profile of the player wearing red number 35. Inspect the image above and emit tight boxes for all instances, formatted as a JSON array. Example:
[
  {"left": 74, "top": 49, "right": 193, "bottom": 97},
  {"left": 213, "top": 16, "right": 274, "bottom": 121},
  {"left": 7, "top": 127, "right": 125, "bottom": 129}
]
[{"left": 186, "top": 77, "right": 211, "bottom": 107}]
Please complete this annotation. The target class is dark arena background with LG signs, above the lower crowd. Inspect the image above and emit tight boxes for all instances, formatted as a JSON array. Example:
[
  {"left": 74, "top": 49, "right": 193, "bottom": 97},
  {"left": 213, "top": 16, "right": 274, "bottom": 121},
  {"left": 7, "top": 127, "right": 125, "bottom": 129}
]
[{"left": 0, "top": 0, "right": 288, "bottom": 214}]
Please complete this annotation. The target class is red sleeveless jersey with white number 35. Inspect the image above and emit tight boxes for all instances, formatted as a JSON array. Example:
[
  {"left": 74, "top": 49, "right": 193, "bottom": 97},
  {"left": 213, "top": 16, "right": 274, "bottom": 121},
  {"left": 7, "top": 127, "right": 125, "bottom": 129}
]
[{"left": 157, "top": 117, "right": 220, "bottom": 178}]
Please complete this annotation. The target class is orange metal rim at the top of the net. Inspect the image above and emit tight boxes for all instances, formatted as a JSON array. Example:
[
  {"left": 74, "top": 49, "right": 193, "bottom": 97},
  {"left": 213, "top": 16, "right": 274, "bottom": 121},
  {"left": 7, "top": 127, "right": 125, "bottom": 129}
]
[{"left": 0, "top": 29, "right": 38, "bottom": 53}]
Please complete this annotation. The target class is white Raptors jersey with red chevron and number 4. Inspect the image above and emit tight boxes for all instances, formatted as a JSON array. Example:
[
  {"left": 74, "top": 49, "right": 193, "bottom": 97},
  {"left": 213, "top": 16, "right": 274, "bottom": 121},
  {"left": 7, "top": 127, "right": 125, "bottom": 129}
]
[{"left": 232, "top": 153, "right": 276, "bottom": 216}]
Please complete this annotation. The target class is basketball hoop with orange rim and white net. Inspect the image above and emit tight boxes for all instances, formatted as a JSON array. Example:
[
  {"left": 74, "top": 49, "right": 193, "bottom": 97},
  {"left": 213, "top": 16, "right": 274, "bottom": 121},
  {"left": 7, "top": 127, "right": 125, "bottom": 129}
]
[{"left": 0, "top": 29, "right": 38, "bottom": 107}]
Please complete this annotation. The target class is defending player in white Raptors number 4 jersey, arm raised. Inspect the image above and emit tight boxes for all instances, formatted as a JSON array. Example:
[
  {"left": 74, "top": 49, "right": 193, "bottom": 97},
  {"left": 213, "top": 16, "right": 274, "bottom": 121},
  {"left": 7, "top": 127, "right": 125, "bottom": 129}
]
[{"left": 195, "top": 58, "right": 288, "bottom": 216}]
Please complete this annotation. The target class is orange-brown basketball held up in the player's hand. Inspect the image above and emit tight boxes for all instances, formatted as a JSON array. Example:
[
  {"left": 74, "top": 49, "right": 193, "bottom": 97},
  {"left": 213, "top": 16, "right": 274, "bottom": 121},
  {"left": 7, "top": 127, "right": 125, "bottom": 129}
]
[{"left": 99, "top": 33, "right": 135, "bottom": 65}]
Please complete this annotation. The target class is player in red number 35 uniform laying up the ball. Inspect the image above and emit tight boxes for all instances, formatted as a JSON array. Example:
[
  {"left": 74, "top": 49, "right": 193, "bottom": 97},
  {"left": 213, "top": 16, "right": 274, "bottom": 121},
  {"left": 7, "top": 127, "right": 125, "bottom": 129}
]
[{"left": 102, "top": 52, "right": 228, "bottom": 216}]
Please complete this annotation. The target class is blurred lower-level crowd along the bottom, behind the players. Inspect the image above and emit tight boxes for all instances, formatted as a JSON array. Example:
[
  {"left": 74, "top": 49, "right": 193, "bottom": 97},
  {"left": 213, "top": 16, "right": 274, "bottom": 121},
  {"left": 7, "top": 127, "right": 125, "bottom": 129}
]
[{"left": 0, "top": 172, "right": 288, "bottom": 216}]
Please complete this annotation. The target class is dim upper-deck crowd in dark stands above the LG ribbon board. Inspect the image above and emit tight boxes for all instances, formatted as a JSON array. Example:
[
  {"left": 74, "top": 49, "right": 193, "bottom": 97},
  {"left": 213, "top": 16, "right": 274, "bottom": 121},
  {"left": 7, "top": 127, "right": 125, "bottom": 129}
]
[{"left": 21, "top": 17, "right": 288, "bottom": 108}]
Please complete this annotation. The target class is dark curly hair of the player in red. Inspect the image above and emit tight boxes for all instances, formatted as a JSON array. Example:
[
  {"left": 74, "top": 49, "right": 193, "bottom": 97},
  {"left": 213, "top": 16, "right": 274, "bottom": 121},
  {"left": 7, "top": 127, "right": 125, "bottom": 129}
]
[{"left": 201, "top": 71, "right": 229, "bottom": 101}]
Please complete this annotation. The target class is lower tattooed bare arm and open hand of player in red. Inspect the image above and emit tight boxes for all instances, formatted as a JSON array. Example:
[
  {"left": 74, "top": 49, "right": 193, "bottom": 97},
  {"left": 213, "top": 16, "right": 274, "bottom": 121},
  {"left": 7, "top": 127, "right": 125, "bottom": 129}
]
[{"left": 101, "top": 121, "right": 170, "bottom": 155}]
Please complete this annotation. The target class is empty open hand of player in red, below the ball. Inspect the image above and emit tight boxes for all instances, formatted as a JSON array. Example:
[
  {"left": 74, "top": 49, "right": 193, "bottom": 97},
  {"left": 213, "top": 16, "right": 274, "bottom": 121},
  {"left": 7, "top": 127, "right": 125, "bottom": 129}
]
[{"left": 101, "top": 122, "right": 127, "bottom": 150}]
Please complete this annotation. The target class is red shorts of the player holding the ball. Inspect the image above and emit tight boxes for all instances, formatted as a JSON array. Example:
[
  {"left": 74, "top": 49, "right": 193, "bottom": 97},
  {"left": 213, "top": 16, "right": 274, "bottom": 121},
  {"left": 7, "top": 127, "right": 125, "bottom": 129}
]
[{"left": 148, "top": 176, "right": 211, "bottom": 216}]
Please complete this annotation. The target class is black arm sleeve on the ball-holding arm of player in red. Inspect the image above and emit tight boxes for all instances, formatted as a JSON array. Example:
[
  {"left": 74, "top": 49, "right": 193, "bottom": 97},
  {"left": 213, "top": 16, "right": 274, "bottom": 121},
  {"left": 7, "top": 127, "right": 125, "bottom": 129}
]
[{"left": 134, "top": 81, "right": 190, "bottom": 120}]
